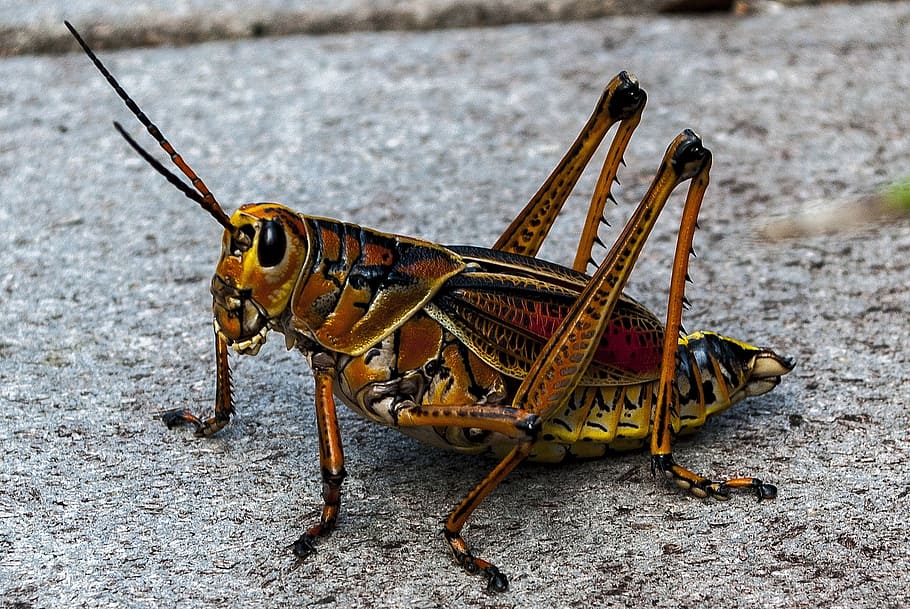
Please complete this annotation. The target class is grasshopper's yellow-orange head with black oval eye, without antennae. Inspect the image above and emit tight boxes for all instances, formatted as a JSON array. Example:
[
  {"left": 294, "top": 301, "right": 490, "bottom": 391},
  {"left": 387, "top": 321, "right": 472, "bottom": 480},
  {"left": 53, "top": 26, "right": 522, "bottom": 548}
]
[{"left": 212, "top": 203, "right": 307, "bottom": 355}]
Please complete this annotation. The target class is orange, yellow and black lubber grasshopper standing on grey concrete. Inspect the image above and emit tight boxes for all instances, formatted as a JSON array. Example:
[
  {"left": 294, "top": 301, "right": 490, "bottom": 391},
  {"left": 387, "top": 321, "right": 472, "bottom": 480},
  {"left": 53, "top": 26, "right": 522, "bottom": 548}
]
[{"left": 67, "top": 23, "right": 793, "bottom": 590}]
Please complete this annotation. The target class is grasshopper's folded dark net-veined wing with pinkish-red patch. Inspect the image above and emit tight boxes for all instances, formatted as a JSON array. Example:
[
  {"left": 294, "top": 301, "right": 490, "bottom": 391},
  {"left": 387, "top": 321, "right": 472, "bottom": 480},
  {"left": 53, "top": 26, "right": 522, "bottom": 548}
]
[{"left": 426, "top": 246, "right": 664, "bottom": 386}]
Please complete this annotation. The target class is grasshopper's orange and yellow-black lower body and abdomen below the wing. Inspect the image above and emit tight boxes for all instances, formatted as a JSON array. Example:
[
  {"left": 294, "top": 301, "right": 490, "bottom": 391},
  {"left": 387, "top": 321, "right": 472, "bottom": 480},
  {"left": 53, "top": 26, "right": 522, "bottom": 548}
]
[{"left": 336, "top": 313, "right": 784, "bottom": 462}]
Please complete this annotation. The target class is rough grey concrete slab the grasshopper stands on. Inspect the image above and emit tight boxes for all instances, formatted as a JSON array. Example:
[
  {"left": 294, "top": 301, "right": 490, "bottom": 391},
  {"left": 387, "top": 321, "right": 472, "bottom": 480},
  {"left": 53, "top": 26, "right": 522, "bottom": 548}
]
[{"left": 0, "top": 2, "right": 910, "bottom": 609}]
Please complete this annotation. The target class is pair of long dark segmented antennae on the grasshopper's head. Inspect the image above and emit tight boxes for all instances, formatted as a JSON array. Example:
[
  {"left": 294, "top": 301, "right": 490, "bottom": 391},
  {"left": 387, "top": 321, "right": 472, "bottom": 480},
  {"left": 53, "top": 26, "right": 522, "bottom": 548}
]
[{"left": 63, "top": 21, "right": 245, "bottom": 236}]
